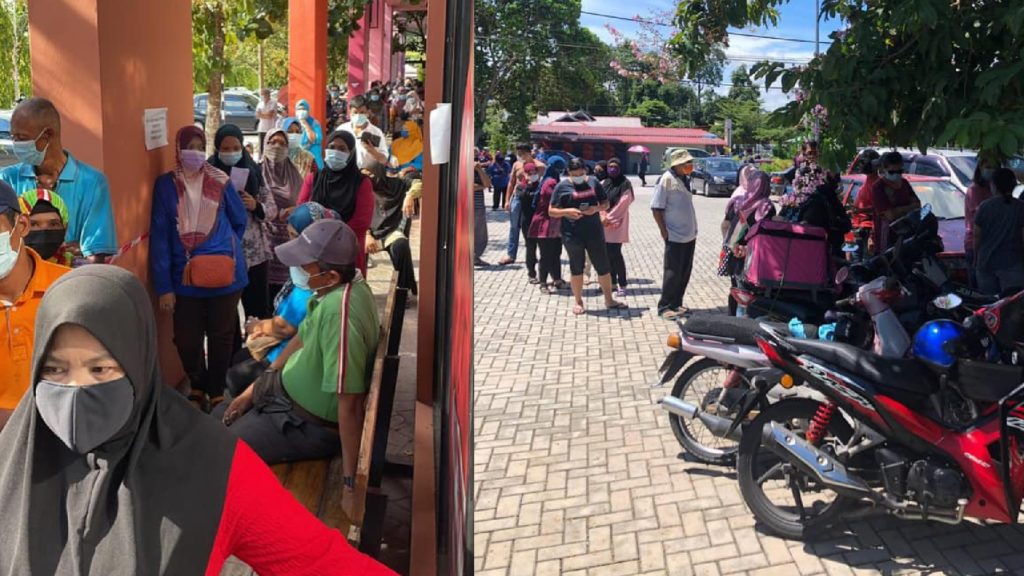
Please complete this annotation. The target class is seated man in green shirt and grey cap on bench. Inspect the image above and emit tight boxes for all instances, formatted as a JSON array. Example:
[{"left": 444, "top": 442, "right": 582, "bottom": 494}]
[{"left": 223, "top": 220, "right": 380, "bottom": 488}]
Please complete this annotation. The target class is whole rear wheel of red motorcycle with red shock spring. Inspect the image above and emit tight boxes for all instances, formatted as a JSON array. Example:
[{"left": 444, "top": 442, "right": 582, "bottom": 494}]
[{"left": 736, "top": 399, "right": 854, "bottom": 540}]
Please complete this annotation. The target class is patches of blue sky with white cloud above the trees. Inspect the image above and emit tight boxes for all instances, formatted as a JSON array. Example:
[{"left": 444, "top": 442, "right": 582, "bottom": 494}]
[{"left": 580, "top": 0, "right": 840, "bottom": 110}]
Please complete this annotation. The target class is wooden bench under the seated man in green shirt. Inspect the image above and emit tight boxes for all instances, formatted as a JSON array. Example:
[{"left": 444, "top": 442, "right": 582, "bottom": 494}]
[{"left": 273, "top": 273, "right": 409, "bottom": 557}]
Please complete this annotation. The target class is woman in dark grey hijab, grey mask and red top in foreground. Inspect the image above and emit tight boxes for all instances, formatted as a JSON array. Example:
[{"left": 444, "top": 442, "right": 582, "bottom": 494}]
[{"left": 0, "top": 264, "right": 391, "bottom": 575}]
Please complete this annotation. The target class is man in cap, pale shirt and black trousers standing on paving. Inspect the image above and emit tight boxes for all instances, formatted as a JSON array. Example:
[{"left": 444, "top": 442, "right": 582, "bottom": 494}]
[{"left": 650, "top": 150, "right": 697, "bottom": 320}]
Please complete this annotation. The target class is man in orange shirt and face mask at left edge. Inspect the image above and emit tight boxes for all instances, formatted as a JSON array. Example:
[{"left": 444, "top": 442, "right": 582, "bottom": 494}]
[{"left": 0, "top": 182, "right": 71, "bottom": 429}]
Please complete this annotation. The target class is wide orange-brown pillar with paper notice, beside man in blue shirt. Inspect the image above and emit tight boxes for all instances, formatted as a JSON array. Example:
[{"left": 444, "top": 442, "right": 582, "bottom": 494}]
[{"left": 29, "top": 0, "right": 193, "bottom": 383}]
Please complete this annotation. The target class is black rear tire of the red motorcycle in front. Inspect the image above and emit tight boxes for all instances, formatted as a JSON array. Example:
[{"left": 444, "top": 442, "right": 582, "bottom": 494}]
[{"left": 736, "top": 398, "right": 855, "bottom": 540}]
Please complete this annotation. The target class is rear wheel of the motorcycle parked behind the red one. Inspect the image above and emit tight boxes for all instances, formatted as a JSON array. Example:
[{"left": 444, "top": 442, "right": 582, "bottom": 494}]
[{"left": 669, "top": 358, "right": 751, "bottom": 465}]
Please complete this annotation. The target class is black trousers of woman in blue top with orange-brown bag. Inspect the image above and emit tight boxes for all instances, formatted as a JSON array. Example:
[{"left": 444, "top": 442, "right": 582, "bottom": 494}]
[{"left": 174, "top": 291, "right": 242, "bottom": 398}]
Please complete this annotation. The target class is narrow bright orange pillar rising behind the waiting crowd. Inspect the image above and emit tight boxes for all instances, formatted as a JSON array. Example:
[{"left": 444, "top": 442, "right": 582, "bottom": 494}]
[{"left": 288, "top": 0, "right": 327, "bottom": 125}]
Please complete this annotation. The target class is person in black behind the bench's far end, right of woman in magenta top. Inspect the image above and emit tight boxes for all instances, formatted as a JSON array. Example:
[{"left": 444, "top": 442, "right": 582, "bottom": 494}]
[{"left": 362, "top": 161, "right": 422, "bottom": 295}]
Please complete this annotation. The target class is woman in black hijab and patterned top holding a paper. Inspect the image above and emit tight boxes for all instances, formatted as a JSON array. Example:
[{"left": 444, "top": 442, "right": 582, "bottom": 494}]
[{"left": 207, "top": 124, "right": 278, "bottom": 318}]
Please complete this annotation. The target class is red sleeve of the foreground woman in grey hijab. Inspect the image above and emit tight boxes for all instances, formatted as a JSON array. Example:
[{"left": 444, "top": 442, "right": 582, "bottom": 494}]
[{"left": 206, "top": 441, "right": 395, "bottom": 576}]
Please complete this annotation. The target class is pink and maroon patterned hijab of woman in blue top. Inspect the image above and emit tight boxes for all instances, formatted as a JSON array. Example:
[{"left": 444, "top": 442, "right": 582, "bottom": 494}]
[{"left": 172, "top": 125, "right": 228, "bottom": 252}]
